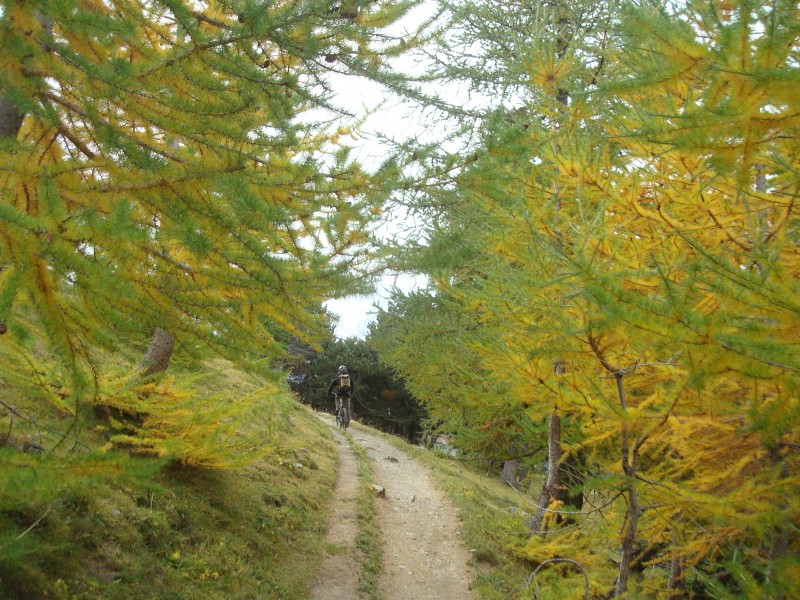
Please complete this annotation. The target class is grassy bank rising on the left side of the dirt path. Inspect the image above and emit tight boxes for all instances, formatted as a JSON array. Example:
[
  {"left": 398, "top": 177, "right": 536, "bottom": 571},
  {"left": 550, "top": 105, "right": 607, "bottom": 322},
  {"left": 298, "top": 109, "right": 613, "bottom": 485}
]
[{"left": 0, "top": 358, "right": 336, "bottom": 600}]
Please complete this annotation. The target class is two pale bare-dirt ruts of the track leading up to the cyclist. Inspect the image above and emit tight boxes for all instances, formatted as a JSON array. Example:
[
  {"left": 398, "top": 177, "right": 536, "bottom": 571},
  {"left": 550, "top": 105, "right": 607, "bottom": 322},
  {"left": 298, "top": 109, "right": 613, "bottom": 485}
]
[{"left": 312, "top": 417, "right": 473, "bottom": 600}]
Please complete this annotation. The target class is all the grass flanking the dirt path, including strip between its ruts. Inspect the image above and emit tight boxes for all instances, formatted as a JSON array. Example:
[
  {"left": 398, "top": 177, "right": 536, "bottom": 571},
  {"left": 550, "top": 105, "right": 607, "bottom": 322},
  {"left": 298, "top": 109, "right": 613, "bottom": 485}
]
[{"left": 0, "top": 356, "right": 548, "bottom": 600}]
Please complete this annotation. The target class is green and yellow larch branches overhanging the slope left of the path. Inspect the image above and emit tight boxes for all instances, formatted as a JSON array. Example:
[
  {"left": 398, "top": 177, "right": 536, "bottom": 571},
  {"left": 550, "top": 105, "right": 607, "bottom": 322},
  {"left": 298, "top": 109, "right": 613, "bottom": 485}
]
[{"left": 0, "top": 0, "right": 424, "bottom": 399}]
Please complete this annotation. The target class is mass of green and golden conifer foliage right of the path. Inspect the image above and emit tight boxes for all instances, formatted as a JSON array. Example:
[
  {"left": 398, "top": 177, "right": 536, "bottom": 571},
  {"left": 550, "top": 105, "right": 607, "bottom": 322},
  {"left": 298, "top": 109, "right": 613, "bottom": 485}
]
[{"left": 381, "top": 1, "right": 800, "bottom": 598}]
